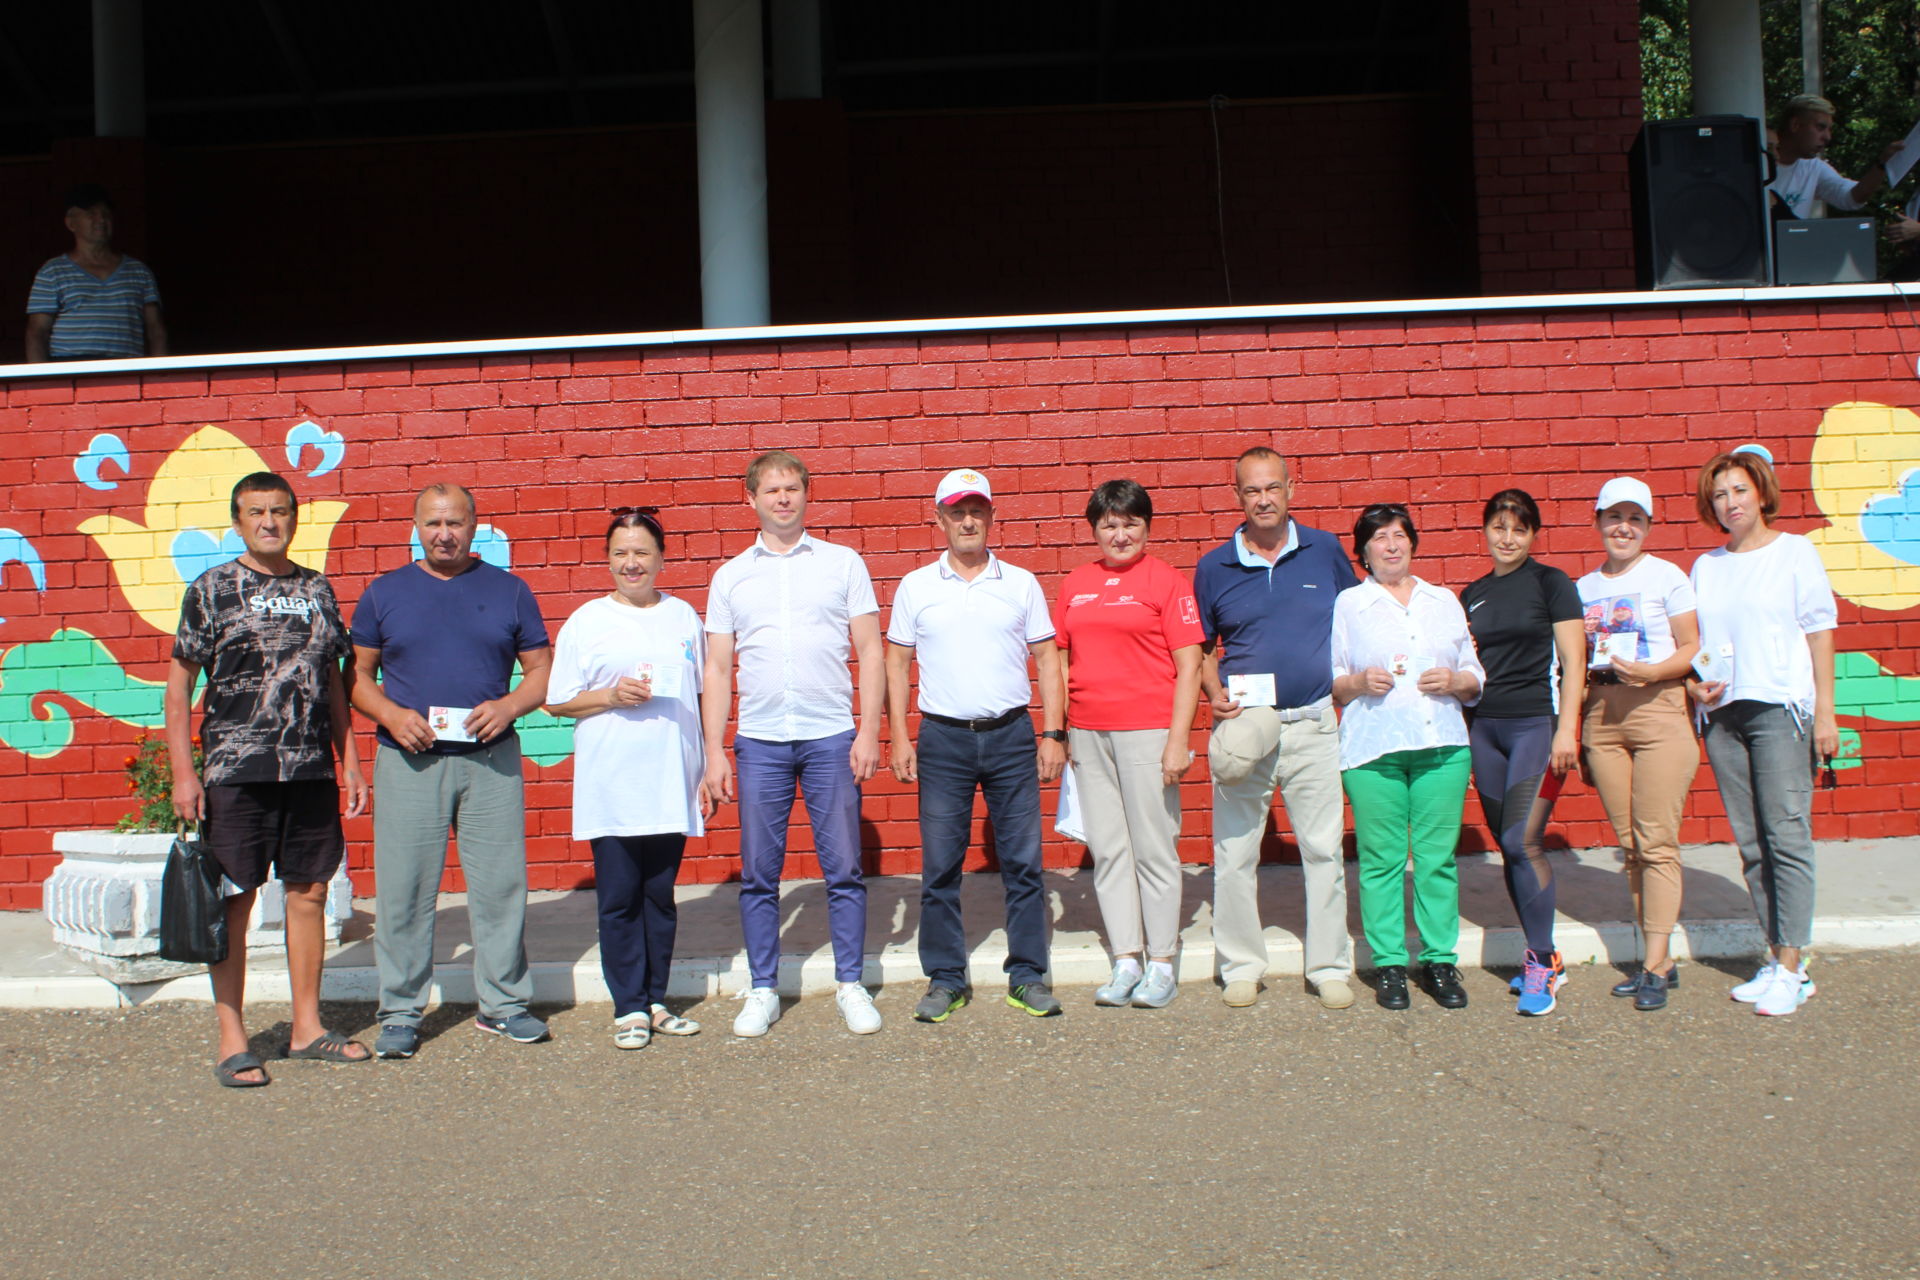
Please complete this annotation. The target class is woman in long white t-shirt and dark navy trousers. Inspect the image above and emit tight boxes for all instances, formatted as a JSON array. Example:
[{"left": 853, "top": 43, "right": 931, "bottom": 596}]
[{"left": 547, "top": 507, "right": 708, "bottom": 1050}]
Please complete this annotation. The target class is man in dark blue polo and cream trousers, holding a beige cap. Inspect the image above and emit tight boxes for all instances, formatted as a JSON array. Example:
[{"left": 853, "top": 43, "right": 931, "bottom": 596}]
[{"left": 1194, "top": 447, "right": 1357, "bottom": 1009}]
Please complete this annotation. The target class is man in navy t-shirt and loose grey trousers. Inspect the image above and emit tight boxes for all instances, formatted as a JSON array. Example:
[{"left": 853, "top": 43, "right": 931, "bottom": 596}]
[{"left": 353, "top": 484, "right": 553, "bottom": 1057}]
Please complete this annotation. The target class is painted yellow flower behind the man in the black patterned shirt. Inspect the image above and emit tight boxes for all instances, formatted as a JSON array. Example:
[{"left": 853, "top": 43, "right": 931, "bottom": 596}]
[{"left": 79, "top": 426, "right": 348, "bottom": 635}]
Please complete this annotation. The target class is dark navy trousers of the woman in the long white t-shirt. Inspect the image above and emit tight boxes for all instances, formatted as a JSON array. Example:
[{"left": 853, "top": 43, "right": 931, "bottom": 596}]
[{"left": 593, "top": 833, "right": 687, "bottom": 1017}]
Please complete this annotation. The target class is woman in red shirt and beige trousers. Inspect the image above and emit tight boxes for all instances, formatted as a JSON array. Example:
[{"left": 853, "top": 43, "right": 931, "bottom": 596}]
[{"left": 1054, "top": 480, "right": 1204, "bottom": 1009}]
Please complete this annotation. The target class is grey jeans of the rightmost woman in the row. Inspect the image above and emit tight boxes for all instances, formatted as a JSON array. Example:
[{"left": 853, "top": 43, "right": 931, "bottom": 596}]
[{"left": 1707, "top": 700, "right": 1812, "bottom": 946}]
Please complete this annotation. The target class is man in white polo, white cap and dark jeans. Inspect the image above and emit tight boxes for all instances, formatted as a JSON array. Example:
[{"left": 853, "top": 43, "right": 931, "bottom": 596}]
[{"left": 887, "top": 468, "right": 1068, "bottom": 1023}]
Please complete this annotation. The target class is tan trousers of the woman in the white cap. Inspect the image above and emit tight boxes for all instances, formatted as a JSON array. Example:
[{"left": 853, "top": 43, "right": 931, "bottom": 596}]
[{"left": 1580, "top": 679, "right": 1699, "bottom": 935}]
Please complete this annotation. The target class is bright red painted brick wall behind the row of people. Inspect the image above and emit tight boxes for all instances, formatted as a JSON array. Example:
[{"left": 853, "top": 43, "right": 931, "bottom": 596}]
[{"left": 0, "top": 301, "right": 1920, "bottom": 908}]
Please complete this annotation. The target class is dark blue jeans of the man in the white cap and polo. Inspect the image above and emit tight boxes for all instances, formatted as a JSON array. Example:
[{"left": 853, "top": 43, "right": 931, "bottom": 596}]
[{"left": 920, "top": 716, "right": 1048, "bottom": 988}]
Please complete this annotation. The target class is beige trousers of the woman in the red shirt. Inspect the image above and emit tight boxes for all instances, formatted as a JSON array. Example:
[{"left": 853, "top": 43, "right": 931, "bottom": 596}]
[{"left": 1068, "top": 729, "right": 1181, "bottom": 960}]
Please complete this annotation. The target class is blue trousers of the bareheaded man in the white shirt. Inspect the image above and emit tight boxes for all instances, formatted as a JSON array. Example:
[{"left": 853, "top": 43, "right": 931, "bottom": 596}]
[{"left": 733, "top": 729, "right": 866, "bottom": 986}]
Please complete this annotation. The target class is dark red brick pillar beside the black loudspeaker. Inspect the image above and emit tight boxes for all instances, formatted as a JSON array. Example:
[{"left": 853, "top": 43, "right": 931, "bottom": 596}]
[{"left": 1471, "top": 0, "right": 1642, "bottom": 297}]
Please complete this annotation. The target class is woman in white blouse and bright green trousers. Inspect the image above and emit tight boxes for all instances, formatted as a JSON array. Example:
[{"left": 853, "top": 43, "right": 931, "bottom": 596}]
[{"left": 1332, "top": 503, "right": 1486, "bottom": 1009}]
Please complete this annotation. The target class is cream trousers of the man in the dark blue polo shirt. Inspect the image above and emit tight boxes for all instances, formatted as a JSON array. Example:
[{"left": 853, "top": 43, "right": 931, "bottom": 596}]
[{"left": 1213, "top": 706, "right": 1354, "bottom": 986}]
